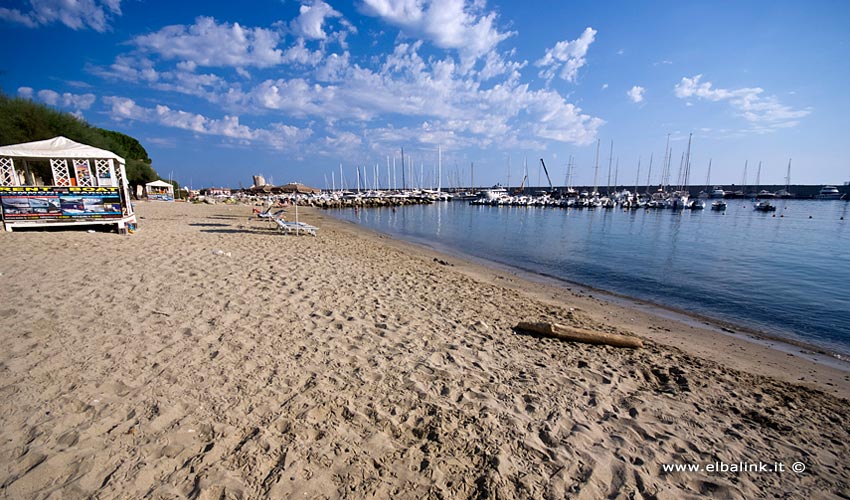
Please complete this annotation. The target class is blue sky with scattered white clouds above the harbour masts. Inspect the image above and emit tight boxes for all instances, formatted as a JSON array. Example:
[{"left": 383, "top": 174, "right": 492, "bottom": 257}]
[{"left": 0, "top": 0, "right": 850, "bottom": 187}]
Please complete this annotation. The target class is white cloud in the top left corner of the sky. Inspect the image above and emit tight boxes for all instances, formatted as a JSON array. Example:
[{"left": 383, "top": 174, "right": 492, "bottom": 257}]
[{"left": 0, "top": 0, "right": 121, "bottom": 33}]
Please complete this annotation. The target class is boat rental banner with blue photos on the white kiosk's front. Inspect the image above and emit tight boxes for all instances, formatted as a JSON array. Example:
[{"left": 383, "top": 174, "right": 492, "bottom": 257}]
[{"left": 0, "top": 186, "right": 121, "bottom": 220}]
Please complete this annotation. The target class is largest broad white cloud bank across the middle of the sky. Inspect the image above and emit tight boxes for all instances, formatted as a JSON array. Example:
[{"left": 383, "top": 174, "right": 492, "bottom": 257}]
[{"left": 233, "top": 38, "right": 604, "bottom": 146}]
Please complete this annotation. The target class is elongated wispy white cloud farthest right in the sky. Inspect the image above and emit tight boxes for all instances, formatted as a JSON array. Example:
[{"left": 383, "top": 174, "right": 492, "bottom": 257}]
[{"left": 674, "top": 75, "right": 811, "bottom": 131}]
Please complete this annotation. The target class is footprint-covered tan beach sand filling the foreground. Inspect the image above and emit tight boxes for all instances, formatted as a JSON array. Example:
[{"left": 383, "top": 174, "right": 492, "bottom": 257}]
[{"left": 0, "top": 203, "right": 850, "bottom": 499}]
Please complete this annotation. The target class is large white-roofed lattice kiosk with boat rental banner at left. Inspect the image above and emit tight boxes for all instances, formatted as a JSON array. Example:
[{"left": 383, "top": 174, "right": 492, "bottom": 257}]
[{"left": 0, "top": 137, "right": 136, "bottom": 233}]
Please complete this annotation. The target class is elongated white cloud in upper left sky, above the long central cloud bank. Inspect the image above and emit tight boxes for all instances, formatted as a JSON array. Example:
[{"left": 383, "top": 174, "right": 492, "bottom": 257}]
[{"left": 133, "top": 17, "right": 283, "bottom": 68}]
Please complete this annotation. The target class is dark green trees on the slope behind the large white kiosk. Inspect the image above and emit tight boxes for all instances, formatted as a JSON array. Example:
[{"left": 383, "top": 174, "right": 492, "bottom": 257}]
[{"left": 0, "top": 93, "right": 159, "bottom": 186}]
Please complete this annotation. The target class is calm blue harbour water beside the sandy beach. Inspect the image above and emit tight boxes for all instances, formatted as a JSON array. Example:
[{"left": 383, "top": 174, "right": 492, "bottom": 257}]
[{"left": 336, "top": 200, "right": 850, "bottom": 357}]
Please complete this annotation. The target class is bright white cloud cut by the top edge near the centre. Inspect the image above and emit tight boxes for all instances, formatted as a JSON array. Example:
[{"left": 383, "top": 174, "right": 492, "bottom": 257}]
[{"left": 362, "top": 0, "right": 514, "bottom": 60}]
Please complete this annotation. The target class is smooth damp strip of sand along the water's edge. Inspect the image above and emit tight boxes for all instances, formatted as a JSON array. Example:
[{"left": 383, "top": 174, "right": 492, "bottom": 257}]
[{"left": 313, "top": 209, "right": 850, "bottom": 398}]
